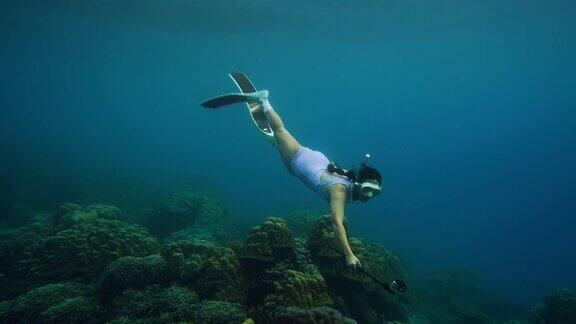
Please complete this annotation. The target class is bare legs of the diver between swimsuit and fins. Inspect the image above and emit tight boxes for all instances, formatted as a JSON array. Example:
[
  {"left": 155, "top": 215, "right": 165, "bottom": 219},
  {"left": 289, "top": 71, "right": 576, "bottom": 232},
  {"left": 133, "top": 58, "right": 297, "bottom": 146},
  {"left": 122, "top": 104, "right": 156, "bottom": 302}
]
[{"left": 260, "top": 98, "right": 302, "bottom": 167}]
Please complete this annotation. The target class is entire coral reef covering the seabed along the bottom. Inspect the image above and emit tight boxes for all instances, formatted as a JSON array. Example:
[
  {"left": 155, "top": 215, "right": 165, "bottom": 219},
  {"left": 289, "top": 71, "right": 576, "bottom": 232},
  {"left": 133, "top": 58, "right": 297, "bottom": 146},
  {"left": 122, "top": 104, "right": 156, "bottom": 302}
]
[{"left": 0, "top": 191, "right": 564, "bottom": 324}]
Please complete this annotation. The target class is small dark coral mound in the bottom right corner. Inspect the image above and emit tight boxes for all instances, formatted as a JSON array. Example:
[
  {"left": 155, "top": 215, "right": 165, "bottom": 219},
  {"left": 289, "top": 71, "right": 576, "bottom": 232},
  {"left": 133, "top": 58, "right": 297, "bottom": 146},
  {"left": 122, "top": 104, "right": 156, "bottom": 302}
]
[{"left": 532, "top": 289, "right": 576, "bottom": 324}]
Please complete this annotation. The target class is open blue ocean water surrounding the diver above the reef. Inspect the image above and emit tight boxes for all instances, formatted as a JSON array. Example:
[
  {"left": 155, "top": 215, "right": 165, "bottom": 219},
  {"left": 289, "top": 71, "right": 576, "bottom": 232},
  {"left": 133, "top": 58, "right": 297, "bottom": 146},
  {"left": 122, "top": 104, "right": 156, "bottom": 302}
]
[{"left": 0, "top": 0, "right": 576, "bottom": 306}]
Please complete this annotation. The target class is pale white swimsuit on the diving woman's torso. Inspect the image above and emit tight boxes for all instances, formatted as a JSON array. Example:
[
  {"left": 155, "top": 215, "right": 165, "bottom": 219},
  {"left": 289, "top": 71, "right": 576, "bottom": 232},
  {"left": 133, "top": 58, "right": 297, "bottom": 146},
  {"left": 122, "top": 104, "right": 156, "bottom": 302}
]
[{"left": 288, "top": 147, "right": 354, "bottom": 202}]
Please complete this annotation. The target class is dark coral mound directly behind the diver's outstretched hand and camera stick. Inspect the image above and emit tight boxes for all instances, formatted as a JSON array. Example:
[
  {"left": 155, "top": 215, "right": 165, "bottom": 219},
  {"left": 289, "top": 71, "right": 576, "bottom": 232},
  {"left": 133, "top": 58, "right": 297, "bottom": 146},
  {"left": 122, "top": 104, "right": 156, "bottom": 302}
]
[{"left": 308, "top": 216, "right": 410, "bottom": 323}]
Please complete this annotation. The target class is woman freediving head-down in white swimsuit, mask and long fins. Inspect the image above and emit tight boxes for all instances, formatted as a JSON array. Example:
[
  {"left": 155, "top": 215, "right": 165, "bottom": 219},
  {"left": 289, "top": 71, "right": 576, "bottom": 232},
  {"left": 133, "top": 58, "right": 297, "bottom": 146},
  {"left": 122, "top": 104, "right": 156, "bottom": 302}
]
[{"left": 202, "top": 74, "right": 382, "bottom": 268}]
